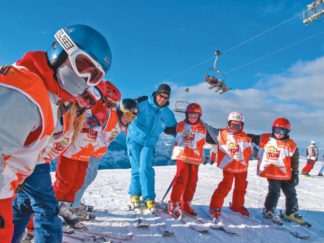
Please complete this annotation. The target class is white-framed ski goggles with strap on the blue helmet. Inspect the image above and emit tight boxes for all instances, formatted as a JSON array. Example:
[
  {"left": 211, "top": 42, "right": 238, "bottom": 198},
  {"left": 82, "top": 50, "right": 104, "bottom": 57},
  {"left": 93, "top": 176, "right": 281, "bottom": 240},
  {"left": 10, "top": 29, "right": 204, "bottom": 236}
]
[{"left": 54, "top": 29, "right": 105, "bottom": 86}]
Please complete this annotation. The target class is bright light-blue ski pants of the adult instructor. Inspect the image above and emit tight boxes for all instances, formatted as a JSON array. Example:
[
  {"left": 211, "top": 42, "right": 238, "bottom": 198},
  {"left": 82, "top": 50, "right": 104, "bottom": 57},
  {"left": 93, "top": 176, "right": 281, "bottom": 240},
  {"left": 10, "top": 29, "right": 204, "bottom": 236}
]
[{"left": 127, "top": 139, "right": 156, "bottom": 201}]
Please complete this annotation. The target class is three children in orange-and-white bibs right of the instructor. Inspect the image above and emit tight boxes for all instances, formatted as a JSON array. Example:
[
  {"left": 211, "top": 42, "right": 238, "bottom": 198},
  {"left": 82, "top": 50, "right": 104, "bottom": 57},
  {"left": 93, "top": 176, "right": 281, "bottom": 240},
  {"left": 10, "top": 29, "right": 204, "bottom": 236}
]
[{"left": 168, "top": 103, "right": 304, "bottom": 224}]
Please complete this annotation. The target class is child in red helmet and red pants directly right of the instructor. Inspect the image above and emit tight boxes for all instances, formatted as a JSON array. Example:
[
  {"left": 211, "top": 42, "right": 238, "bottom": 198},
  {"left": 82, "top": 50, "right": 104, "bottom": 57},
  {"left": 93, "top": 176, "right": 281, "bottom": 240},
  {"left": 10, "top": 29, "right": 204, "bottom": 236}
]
[{"left": 168, "top": 103, "right": 215, "bottom": 217}]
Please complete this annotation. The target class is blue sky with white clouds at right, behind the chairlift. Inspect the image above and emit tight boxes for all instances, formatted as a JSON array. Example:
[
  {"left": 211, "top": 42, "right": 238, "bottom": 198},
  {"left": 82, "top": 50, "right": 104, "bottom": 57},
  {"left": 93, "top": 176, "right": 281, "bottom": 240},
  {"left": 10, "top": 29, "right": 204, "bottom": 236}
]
[{"left": 0, "top": 0, "right": 324, "bottom": 151}]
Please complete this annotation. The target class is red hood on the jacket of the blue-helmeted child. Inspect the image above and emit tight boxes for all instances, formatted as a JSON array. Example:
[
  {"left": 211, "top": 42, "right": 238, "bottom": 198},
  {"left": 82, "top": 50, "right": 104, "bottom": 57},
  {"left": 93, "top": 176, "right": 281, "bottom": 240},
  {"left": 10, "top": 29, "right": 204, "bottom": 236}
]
[{"left": 16, "top": 51, "right": 75, "bottom": 101}]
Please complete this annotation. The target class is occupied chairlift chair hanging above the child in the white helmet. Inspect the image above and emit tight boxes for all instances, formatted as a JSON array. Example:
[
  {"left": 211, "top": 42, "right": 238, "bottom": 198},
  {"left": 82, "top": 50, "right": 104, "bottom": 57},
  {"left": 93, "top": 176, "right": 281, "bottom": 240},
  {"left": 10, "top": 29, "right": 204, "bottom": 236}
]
[{"left": 204, "top": 50, "right": 230, "bottom": 94}]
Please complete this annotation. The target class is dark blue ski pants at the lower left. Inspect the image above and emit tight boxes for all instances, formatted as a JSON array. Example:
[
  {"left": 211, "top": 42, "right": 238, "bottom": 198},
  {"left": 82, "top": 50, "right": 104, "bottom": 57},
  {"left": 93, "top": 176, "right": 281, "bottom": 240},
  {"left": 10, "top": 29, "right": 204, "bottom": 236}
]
[{"left": 12, "top": 164, "right": 62, "bottom": 243}]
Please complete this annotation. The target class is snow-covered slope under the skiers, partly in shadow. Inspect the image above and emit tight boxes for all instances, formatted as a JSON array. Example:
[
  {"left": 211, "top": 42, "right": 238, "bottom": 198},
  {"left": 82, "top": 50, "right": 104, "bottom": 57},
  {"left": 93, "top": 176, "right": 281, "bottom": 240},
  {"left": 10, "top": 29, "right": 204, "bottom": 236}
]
[{"left": 63, "top": 160, "right": 324, "bottom": 243}]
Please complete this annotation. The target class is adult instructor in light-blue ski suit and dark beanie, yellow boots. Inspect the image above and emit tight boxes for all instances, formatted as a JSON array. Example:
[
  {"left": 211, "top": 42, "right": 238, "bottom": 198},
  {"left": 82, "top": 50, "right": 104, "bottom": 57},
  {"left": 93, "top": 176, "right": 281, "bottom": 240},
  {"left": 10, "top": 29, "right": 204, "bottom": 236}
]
[{"left": 126, "top": 84, "right": 177, "bottom": 211}]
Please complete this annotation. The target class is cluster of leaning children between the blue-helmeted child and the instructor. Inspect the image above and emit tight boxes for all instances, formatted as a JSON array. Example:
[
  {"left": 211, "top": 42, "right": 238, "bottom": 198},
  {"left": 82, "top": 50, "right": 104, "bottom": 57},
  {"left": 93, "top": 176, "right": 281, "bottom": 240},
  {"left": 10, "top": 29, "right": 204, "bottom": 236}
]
[{"left": 12, "top": 81, "right": 138, "bottom": 242}]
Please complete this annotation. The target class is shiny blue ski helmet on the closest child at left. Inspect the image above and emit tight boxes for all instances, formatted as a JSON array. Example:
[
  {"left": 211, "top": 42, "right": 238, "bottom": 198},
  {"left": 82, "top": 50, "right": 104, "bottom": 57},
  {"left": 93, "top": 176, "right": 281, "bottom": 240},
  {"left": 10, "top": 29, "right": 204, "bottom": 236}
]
[{"left": 47, "top": 24, "right": 112, "bottom": 73}]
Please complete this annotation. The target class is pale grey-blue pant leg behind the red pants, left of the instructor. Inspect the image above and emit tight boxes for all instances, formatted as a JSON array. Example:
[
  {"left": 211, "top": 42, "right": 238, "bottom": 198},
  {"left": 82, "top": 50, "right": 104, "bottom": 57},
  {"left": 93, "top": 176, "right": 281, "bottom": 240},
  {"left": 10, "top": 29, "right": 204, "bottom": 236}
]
[{"left": 72, "top": 157, "right": 101, "bottom": 208}]
